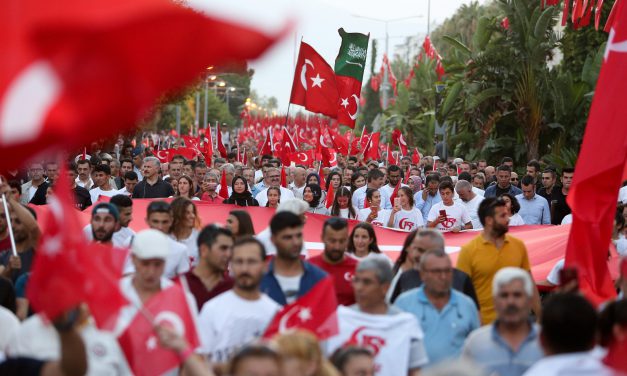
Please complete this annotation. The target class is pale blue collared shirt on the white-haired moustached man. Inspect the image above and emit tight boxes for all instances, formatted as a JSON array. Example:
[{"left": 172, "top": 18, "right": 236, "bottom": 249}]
[{"left": 462, "top": 322, "right": 544, "bottom": 376}]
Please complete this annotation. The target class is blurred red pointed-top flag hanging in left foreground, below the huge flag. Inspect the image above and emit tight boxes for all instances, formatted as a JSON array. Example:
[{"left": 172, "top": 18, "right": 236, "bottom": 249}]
[{"left": 26, "top": 168, "right": 126, "bottom": 329}]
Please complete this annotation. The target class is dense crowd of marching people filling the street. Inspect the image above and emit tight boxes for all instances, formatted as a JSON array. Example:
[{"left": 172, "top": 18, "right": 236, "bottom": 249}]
[{"left": 0, "top": 131, "right": 627, "bottom": 376}]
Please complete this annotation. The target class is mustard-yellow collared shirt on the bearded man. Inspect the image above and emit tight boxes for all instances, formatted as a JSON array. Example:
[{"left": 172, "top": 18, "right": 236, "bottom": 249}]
[{"left": 457, "top": 234, "right": 531, "bottom": 325}]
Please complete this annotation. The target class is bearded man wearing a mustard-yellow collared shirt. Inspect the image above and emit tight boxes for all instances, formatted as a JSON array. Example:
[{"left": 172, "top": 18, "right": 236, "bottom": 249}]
[{"left": 457, "top": 197, "right": 540, "bottom": 325}]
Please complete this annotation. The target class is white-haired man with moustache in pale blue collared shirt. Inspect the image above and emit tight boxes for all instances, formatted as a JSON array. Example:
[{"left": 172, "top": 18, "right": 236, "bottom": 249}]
[{"left": 462, "top": 267, "right": 544, "bottom": 376}]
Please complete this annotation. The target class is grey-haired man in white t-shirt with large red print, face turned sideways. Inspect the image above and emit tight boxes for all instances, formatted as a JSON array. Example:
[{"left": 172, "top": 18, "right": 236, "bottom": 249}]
[{"left": 327, "top": 256, "right": 429, "bottom": 376}]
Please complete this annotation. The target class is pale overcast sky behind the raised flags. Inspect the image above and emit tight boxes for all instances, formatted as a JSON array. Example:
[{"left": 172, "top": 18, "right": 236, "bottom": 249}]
[{"left": 251, "top": 0, "right": 483, "bottom": 113}]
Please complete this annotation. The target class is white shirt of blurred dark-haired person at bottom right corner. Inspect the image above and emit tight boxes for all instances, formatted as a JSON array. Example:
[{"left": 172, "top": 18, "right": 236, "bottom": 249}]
[{"left": 523, "top": 352, "right": 615, "bottom": 376}]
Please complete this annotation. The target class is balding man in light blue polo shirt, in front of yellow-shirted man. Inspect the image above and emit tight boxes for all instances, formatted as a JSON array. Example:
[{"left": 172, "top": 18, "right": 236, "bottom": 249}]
[{"left": 394, "top": 249, "right": 480, "bottom": 364}]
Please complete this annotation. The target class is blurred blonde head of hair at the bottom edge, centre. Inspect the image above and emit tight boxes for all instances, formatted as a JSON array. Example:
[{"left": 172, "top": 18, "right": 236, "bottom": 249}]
[{"left": 272, "top": 330, "right": 340, "bottom": 376}]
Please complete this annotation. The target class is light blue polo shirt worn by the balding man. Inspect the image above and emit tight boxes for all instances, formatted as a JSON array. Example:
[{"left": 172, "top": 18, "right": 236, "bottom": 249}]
[{"left": 394, "top": 286, "right": 481, "bottom": 365}]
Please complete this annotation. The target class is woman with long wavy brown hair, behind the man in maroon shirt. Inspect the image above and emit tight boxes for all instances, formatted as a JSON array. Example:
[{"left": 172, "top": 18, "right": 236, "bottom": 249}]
[{"left": 170, "top": 197, "right": 200, "bottom": 265}]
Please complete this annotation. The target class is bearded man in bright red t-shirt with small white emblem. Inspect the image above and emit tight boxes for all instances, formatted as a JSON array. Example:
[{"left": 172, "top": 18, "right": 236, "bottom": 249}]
[{"left": 309, "top": 217, "right": 357, "bottom": 306}]
